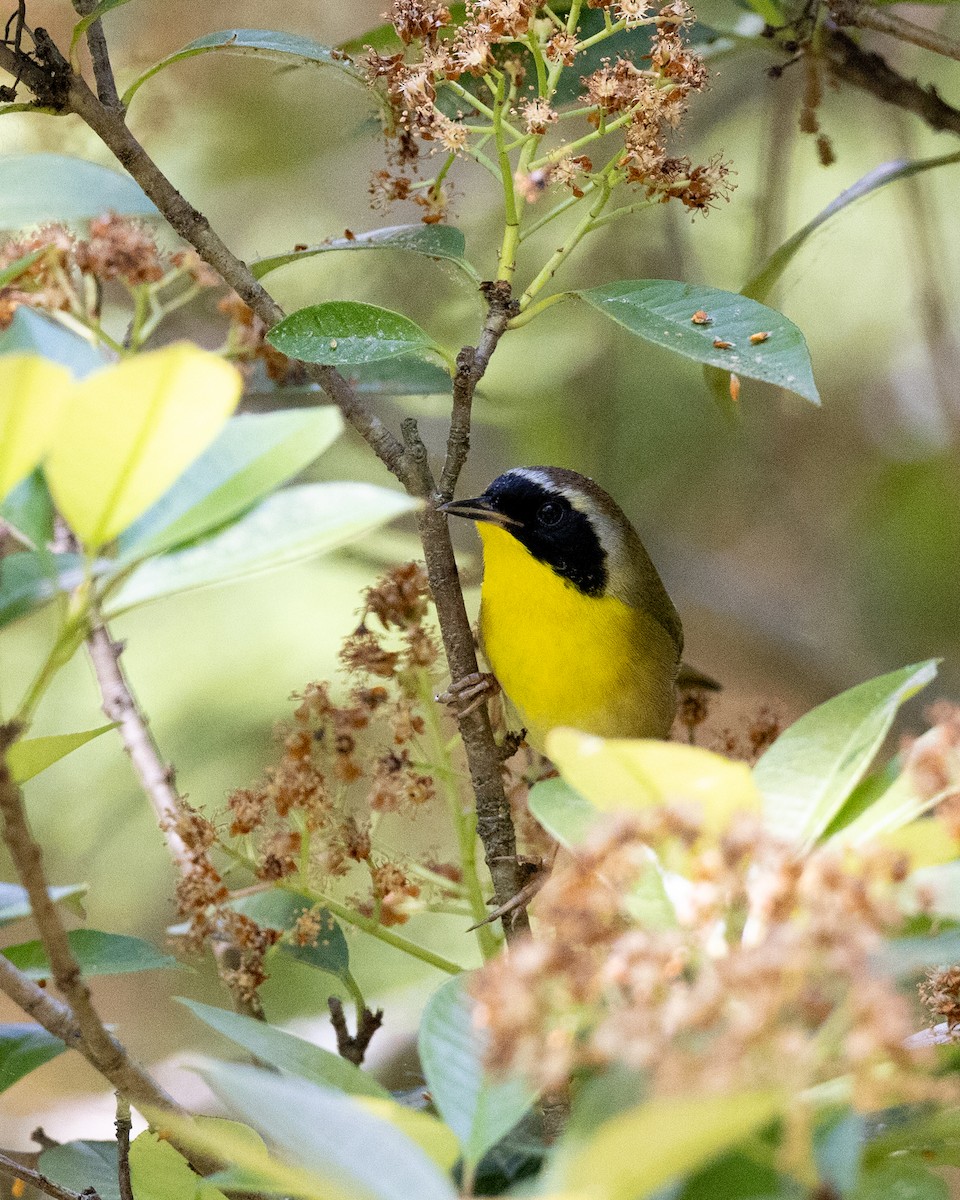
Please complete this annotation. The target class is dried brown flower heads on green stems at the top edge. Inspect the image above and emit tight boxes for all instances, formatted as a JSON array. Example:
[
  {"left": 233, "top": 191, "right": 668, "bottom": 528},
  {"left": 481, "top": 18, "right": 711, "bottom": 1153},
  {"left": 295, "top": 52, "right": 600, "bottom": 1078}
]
[{"left": 366, "top": 0, "right": 728, "bottom": 222}]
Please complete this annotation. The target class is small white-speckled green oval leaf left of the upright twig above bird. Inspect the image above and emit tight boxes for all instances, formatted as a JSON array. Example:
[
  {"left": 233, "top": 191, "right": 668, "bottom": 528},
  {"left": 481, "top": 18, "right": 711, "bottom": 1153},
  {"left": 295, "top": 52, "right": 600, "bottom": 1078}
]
[{"left": 266, "top": 300, "right": 439, "bottom": 367}]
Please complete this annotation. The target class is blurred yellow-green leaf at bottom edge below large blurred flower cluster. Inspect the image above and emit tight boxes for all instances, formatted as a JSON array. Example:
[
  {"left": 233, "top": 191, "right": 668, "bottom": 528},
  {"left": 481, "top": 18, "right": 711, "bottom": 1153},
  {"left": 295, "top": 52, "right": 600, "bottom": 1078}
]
[{"left": 560, "top": 1092, "right": 782, "bottom": 1200}]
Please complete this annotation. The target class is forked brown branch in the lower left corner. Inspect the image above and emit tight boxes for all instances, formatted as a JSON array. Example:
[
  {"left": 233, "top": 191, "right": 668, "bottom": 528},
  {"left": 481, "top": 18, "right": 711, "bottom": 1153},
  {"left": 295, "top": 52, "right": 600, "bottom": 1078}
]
[{"left": 0, "top": 725, "right": 178, "bottom": 1110}]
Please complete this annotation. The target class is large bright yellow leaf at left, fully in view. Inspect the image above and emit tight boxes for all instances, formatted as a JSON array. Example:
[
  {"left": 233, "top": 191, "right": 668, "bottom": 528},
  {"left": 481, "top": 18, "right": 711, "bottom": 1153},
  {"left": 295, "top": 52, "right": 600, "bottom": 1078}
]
[{"left": 46, "top": 342, "right": 242, "bottom": 550}]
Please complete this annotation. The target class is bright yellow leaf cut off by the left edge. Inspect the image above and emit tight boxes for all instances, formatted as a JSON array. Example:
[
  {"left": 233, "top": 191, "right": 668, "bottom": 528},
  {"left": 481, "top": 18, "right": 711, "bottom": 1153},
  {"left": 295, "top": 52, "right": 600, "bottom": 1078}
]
[{"left": 0, "top": 354, "right": 73, "bottom": 500}]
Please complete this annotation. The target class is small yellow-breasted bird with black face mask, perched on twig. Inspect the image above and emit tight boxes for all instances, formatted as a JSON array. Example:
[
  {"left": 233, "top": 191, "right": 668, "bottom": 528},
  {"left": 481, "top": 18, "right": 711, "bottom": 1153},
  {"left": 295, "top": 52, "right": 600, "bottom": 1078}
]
[{"left": 440, "top": 467, "right": 683, "bottom": 749}]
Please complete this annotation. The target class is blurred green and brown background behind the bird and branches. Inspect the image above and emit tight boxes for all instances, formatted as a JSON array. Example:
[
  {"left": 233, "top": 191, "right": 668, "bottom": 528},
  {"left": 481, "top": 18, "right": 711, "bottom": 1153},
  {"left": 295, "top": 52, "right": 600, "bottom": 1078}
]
[{"left": 0, "top": 0, "right": 960, "bottom": 1146}]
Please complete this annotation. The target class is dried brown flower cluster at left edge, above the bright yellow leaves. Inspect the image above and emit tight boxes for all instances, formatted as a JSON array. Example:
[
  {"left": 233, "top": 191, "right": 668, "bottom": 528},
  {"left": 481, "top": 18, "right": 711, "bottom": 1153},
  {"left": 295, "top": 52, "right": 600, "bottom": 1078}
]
[{"left": 0, "top": 212, "right": 213, "bottom": 328}]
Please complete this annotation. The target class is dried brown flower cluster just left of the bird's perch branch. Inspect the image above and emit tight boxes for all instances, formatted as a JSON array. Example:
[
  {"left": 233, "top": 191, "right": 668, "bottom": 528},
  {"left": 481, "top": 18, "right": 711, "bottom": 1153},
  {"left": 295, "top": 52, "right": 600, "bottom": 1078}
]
[{"left": 171, "top": 563, "right": 468, "bottom": 994}]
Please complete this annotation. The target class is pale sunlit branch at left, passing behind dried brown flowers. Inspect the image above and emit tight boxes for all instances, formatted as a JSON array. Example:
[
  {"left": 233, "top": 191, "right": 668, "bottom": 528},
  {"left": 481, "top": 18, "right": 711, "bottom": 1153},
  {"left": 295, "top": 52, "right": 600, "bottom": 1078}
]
[{"left": 86, "top": 610, "right": 264, "bottom": 1020}]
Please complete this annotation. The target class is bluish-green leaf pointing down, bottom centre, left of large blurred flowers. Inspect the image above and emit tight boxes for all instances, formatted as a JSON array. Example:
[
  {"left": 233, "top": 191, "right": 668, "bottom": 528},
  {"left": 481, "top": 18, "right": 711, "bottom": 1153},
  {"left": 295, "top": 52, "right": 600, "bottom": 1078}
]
[{"left": 418, "top": 977, "right": 536, "bottom": 1166}]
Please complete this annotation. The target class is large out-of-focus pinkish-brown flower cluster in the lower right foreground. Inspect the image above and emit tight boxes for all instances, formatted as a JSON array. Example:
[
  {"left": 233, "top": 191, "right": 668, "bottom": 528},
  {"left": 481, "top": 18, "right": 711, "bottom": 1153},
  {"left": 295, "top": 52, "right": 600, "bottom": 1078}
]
[{"left": 474, "top": 809, "right": 938, "bottom": 1104}]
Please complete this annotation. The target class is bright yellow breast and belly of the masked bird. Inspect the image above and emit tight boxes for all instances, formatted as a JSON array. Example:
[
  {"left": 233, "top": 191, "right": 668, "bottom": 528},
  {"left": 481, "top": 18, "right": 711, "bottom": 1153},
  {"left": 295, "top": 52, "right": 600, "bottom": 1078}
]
[{"left": 478, "top": 523, "right": 677, "bottom": 746}]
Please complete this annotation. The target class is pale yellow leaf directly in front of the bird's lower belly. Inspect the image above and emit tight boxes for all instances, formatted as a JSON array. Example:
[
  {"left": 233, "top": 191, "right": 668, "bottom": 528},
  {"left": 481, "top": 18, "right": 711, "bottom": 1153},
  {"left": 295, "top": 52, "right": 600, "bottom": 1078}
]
[{"left": 547, "top": 728, "right": 761, "bottom": 832}]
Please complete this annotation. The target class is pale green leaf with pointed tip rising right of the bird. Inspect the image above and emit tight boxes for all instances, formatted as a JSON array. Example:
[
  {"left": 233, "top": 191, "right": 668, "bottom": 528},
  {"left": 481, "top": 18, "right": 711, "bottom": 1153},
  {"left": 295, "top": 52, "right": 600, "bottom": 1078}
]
[{"left": 754, "top": 660, "right": 937, "bottom": 848}]
